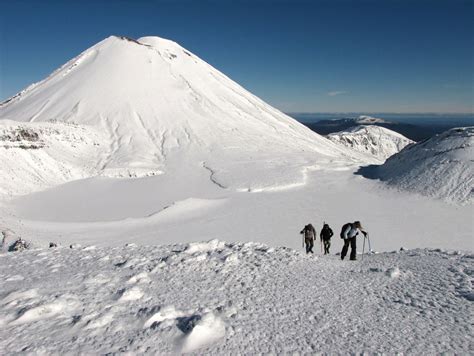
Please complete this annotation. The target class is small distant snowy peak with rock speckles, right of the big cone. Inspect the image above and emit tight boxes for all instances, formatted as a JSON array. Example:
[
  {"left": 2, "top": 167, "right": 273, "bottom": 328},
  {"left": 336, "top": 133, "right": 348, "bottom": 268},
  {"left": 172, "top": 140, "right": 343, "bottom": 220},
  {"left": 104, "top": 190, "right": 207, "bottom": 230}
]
[{"left": 327, "top": 125, "right": 413, "bottom": 162}]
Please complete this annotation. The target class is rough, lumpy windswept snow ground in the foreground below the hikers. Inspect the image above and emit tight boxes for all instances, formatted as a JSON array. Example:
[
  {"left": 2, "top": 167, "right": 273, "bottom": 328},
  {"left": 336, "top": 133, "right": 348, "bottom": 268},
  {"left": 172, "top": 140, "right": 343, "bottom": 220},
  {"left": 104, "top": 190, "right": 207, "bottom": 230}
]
[{"left": 0, "top": 240, "right": 474, "bottom": 355}]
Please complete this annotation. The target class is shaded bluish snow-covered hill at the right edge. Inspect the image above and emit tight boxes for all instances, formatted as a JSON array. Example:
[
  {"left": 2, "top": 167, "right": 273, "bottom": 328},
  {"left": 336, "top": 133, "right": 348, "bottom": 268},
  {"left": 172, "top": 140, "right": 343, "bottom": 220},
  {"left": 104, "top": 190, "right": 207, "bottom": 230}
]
[{"left": 377, "top": 127, "right": 474, "bottom": 203}]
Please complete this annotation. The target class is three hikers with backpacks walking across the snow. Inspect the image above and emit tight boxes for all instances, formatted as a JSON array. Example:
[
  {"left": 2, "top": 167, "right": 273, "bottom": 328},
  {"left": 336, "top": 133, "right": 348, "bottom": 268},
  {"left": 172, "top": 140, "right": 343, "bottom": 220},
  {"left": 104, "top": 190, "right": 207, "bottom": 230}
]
[{"left": 300, "top": 221, "right": 367, "bottom": 260}]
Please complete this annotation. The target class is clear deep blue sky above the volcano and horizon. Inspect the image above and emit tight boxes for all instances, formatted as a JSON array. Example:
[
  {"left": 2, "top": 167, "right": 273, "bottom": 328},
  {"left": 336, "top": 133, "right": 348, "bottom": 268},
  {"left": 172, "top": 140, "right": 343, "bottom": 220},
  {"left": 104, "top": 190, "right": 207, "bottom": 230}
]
[{"left": 0, "top": 0, "right": 474, "bottom": 113}]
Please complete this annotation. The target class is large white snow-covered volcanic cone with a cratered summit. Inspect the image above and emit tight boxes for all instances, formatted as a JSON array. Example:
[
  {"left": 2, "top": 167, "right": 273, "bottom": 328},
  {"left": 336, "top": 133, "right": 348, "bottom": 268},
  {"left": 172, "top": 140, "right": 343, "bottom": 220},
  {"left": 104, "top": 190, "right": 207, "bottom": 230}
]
[{"left": 0, "top": 36, "right": 350, "bottom": 197}]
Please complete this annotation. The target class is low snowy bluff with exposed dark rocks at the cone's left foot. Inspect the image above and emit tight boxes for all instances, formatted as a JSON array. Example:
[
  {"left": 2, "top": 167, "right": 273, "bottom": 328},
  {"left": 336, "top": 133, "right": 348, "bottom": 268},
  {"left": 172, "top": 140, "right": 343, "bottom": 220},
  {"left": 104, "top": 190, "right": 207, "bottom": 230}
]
[{"left": 0, "top": 120, "right": 106, "bottom": 195}]
